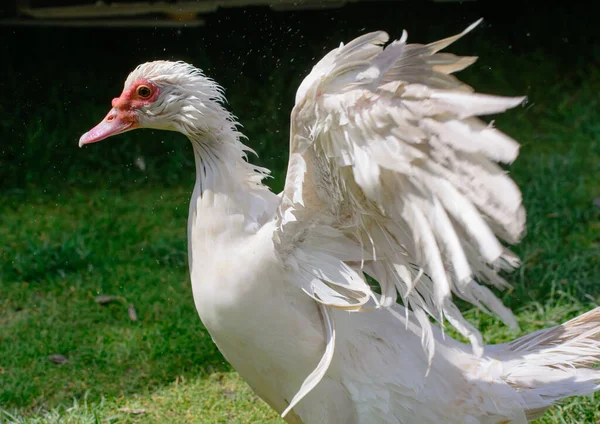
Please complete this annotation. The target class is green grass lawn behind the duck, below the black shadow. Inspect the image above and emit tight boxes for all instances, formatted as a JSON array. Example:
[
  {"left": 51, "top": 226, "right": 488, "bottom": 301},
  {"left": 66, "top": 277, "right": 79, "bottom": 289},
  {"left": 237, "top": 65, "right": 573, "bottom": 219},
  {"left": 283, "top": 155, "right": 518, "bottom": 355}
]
[{"left": 0, "top": 4, "right": 600, "bottom": 423}]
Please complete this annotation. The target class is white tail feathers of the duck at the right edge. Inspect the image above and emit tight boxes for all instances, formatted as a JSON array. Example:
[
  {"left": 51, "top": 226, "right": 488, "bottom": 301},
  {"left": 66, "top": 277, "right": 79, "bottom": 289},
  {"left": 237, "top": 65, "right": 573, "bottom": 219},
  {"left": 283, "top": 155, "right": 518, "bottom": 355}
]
[{"left": 490, "top": 307, "right": 600, "bottom": 419}]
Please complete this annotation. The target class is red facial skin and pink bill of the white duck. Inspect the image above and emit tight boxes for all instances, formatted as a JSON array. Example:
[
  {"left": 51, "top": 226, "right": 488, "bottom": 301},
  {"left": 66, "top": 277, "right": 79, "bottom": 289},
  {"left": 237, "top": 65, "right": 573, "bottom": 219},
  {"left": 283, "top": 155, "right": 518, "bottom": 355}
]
[{"left": 79, "top": 78, "right": 160, "bottom": 147}]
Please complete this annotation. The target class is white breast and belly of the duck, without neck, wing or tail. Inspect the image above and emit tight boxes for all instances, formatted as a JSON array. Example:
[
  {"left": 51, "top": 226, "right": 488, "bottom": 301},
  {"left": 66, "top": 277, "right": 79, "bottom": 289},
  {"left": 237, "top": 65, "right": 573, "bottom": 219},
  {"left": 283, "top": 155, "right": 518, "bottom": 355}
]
[{"left": 189, "top": 199, "right": 526, "bottom": 424}]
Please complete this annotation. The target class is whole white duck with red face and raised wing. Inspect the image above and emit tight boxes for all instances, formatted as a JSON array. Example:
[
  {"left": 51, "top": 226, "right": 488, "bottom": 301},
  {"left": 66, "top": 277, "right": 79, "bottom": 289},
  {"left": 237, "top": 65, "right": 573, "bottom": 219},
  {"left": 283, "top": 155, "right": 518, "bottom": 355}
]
[{"left": 79, "top": 23, "right": 600, "bottom": 423}]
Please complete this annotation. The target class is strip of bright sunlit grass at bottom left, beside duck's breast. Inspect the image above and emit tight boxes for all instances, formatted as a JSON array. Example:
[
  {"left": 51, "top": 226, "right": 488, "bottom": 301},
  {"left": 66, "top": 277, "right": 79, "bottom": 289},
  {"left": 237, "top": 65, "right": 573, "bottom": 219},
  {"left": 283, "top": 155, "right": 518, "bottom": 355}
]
[{"left": 0, "top": 372, "right": 283, "bottom": 424}]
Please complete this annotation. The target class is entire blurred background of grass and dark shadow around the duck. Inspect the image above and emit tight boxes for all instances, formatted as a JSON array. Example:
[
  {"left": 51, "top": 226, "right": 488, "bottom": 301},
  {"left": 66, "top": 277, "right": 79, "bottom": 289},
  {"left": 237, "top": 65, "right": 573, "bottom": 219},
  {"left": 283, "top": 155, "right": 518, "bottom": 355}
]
[{"left": 0, "top": 0, "right": 600, "bottom": 423}]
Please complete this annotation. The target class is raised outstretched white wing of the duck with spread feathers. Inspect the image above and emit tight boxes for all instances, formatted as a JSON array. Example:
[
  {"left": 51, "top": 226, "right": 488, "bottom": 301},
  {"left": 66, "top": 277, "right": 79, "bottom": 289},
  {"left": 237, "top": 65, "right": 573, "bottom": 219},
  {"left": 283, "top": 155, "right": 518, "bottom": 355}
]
[{"left": 274, "top": 21, "right": 525, "bottom": 414}]
